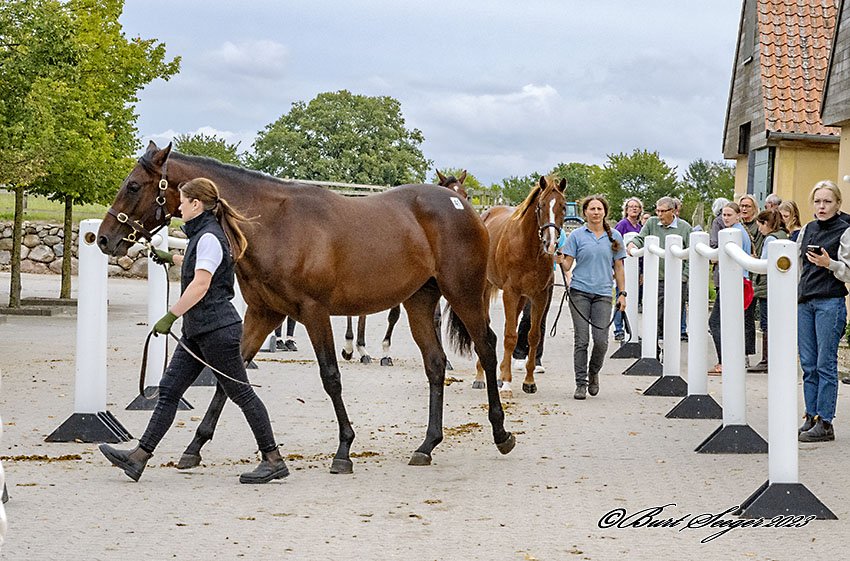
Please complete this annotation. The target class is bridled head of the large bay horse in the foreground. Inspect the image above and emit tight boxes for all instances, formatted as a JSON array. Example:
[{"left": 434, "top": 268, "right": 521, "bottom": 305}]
[{"left": 97, "top": 141, "right": 180, "bottom": 256}]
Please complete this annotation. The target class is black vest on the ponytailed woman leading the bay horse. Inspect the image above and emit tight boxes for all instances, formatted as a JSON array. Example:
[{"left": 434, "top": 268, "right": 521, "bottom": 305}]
[{"left": 180, "top": 211, "right": 242, "bottom": 338}]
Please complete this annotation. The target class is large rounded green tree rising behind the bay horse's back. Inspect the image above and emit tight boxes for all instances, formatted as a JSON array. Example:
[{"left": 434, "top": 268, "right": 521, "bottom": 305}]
[{"left": 247, "top": 90, "right": 431, "bottom": 185}]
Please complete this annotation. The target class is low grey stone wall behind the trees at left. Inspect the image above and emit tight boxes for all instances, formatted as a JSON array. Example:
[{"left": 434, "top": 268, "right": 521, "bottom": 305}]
[{"left": 0, "top": 222, "right": 185, "bottom": 278}]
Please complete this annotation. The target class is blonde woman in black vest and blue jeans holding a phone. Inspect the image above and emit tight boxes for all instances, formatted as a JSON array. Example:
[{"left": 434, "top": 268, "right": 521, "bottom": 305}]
[{"left": 797, "top": 181, "right": 850, "bottom": 442}]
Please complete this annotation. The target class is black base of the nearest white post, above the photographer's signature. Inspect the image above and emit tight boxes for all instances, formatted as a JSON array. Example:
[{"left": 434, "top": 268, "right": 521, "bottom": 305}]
[{"left": 734, "top": 481, "right": 838, "bottom": 520}]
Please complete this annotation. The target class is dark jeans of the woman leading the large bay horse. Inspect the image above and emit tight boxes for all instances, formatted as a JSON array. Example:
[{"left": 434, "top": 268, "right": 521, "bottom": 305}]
[{"left": 139, "top": 323, "right": 276, "bottom": 453}]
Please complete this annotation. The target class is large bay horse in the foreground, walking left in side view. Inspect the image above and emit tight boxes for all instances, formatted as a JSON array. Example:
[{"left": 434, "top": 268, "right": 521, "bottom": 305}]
[{"left": 97, "top": 142, "right": 516, "bottom": 473}]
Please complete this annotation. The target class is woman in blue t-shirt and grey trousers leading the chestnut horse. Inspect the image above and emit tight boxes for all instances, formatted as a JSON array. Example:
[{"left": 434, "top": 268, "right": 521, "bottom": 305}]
[{"left": 562, "top": 195, "right": 626, "bottom": 399}]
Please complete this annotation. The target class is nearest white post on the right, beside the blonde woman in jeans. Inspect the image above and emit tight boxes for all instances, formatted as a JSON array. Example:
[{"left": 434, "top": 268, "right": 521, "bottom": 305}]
[{"left": 767, "top": 240, "right": 799, "bottom": 483}]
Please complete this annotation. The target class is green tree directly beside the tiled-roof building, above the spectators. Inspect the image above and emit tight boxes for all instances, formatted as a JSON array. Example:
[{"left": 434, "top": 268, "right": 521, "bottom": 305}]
[{"left": 682, "top": 159, "right": 735, "bottom": 228}]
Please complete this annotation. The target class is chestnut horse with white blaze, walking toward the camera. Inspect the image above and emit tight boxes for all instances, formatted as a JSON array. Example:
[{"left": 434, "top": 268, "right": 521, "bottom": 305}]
[{"left": 473, "top": 177, "right": 567, "bottom": 396}]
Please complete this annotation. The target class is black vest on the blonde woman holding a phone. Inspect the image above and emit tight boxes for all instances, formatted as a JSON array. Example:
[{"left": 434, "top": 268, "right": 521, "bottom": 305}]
[{"left": 797, "top": 214, "right": 850, "bottom": 304}]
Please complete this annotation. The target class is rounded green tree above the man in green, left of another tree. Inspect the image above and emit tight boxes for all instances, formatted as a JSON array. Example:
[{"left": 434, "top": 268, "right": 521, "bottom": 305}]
[{"left": 598, "top": 149, "right": 679, "bottom": 217}]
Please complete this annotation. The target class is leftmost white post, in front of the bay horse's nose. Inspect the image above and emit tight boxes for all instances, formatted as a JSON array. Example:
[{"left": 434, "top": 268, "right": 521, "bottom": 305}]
[{"left": 74, "top": 220, "right": 108, "bottom": 413}]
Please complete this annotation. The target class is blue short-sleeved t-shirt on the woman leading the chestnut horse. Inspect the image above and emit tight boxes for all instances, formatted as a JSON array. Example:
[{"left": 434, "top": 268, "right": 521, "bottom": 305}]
[{"left": 564, "top": 226, "right": 626, "bottom": 296}]
